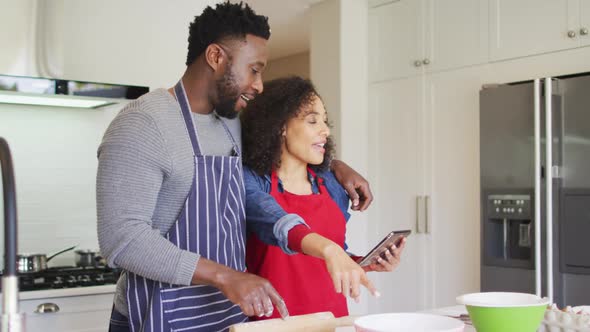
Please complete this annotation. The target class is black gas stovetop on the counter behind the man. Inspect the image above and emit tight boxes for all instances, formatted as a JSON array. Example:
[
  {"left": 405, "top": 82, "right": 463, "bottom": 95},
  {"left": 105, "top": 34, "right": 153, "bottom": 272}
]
[{"left": 1, "top": 266, "right": 121, "bottom": 291}]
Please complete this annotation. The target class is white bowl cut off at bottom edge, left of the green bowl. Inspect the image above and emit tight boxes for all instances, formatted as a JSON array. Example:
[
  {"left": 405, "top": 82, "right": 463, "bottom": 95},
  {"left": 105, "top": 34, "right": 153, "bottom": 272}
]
[{"left": 354, "top": 313, "right": 465, "bottom": 332}]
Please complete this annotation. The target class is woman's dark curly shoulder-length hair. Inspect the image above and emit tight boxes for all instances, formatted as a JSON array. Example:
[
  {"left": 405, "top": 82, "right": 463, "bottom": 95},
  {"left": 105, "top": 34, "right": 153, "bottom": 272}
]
[{"left": 240, "top": 76, "right": 334, "bottom": 175}]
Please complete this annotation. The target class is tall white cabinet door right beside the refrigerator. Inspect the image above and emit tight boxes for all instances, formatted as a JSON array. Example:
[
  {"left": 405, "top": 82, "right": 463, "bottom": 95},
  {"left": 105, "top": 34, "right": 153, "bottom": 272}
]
[{"left": 425, "top": 66, "right": 482, "bottom": 307}]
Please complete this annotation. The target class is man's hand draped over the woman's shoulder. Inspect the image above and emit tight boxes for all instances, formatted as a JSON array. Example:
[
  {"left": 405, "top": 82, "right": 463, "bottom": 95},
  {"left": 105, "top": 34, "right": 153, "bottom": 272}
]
[{"left": 331, "top": 160, "right": 373, "bottom": 211}]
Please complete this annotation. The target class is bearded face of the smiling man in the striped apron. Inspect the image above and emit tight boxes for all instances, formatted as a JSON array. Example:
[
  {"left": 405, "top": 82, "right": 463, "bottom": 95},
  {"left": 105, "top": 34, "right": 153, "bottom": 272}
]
[{"left": 213, "top": 35, "right": 268, "bottom": 119}]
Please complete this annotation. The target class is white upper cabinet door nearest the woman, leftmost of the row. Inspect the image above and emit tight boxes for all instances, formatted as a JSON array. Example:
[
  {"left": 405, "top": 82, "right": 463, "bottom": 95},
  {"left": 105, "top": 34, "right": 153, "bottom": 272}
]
[{"left": 369, "top": 0, "right": 423, "bottom": 82}]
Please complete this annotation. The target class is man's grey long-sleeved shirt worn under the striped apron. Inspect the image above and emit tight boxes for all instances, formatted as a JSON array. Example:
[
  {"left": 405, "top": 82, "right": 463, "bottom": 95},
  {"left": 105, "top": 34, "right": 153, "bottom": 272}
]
[{"left": 96, "top": 89, "right": 241, "bottom": 315}]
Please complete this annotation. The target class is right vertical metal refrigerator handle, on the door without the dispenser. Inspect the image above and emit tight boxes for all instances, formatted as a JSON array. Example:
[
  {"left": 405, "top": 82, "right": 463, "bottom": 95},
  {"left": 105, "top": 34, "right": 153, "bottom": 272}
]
[{"left": 545, "top": 77, "right": 553, "bottom": 303}]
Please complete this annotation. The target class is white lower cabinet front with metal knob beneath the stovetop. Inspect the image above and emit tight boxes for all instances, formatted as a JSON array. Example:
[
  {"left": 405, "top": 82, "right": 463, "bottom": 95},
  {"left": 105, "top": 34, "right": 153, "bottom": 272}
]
[{"left": 19, "top": 293, "right": 113, "bottom": 332}]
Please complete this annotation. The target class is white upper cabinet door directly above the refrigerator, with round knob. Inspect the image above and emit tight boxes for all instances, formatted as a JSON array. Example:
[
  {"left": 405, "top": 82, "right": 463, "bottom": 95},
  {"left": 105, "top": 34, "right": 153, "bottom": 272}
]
[{"left": 490, "top": 0, "right": 587, "bottom": 60}]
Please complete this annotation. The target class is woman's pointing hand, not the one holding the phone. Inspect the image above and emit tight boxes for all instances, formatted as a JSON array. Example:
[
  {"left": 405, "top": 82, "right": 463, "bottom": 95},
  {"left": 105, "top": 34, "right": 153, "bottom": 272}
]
[{"left": 322, "top": 243, "right": 380, "bottom": 302}]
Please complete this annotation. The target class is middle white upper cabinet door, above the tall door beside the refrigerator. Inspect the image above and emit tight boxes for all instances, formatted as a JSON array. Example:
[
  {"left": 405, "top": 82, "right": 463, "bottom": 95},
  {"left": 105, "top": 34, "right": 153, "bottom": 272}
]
[{"left": 424, "top": 0, "right": 488, "bottom": 72}]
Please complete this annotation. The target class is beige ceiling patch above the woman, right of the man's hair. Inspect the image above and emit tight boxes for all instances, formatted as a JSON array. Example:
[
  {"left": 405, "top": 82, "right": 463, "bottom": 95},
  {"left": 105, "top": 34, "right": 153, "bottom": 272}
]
[{"left": 240, "top": 0, "right": 323, "bottom": 60}]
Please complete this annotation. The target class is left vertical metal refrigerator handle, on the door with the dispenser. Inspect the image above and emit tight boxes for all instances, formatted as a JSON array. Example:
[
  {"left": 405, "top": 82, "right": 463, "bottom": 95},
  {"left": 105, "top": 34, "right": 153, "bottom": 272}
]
[{"left": 534, "top": 79, "right": 543, "bottom": 296}]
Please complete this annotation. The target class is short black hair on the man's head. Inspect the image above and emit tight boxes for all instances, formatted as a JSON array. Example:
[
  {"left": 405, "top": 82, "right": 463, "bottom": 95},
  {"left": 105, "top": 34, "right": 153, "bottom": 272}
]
[{"left": 186, "top": 1, "right": 270, "bottom": 66}]
